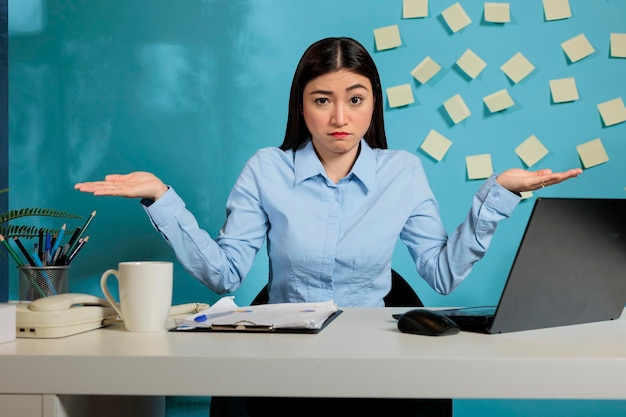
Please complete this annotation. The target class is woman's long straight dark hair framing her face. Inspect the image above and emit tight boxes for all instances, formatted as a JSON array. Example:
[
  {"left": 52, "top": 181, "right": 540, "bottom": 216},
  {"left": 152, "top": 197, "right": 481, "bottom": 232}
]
[{"left": 280, "top": 38, "right": 387, "bottom": 151}]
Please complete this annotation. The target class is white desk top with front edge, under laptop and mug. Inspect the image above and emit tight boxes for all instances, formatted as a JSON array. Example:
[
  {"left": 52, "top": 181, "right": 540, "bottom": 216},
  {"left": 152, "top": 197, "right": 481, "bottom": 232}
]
[{"left": 0, "top": 308, "right": 626, "bottom": 399}]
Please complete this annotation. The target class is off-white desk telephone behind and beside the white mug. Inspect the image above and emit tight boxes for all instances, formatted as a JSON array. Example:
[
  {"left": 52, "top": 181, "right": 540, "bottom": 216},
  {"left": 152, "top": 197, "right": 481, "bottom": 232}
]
[{"left": 16, "top": 293, "right": 209, "bottom": 338}]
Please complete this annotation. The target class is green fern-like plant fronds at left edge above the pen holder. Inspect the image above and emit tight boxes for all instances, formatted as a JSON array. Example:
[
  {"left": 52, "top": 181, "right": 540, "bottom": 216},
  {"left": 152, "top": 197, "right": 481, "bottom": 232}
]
[{"left": 0, "top": 188, "right": 82, "bottom": 239}]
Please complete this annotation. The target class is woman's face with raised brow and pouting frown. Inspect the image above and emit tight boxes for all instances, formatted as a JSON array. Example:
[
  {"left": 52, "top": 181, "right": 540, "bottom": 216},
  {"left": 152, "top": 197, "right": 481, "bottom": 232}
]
[{"left": 302, "top": 69, "right": 374, "bottom": 158}]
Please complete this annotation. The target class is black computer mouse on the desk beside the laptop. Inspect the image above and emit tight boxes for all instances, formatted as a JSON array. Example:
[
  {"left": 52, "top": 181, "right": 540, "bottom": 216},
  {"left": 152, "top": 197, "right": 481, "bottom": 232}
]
[{"left": 398, "top": 308, "right": 461, "bottom": 336}]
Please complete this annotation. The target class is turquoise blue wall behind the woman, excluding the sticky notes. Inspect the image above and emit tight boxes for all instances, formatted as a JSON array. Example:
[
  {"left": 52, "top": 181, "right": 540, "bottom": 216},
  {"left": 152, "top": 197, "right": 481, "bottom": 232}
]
[{"left": 9, "top": 0, "right": 626, "bottom": 415}]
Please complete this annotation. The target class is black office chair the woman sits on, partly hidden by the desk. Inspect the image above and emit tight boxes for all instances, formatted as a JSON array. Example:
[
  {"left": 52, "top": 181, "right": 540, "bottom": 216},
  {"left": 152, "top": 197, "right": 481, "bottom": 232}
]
[{"left": 209, "top": 269, "right": 452, "bottom": 417}]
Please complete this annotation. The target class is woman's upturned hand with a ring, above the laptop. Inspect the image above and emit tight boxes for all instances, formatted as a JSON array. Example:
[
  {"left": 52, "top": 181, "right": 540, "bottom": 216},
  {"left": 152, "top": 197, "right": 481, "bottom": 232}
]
[{"left": 496, "top": 168, "right": 583, "bottom": 193}]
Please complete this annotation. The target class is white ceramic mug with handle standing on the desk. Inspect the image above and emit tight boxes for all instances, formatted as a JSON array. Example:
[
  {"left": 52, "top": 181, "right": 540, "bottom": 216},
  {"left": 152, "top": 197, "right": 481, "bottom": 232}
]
[{"left": 100, "top": 261, "right": 174, "bottom": 332}]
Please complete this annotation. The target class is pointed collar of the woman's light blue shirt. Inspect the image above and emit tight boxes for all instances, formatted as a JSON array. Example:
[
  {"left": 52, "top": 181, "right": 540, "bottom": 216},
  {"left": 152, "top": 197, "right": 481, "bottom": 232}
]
[{"left": 294, "top": 139, "right": 376, "bottom": 190}]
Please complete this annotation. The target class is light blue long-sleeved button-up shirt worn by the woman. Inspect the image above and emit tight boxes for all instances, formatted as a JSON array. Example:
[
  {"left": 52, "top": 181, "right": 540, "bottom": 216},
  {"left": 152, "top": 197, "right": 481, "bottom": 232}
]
[{"left": 145, "top": 140, "right": 520, "bottom": 307}]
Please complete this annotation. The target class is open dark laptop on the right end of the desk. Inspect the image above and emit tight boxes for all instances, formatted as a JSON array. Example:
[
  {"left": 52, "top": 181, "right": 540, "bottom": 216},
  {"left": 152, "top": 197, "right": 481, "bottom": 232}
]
[{"left": 432, "top": 198, "right": 626, "bottom": 334}]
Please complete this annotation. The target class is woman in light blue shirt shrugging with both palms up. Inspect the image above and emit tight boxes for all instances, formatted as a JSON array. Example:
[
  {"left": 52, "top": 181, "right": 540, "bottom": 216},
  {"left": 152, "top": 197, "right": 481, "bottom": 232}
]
[{"left": 75, "top": 38, "right": 581, "bottom": 415}]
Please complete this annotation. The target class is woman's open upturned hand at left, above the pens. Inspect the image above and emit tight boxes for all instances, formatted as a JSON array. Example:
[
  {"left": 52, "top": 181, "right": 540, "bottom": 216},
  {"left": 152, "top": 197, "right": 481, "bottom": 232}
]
[{"left": 74, "top": 171, "right": 167, "bottom": 201}]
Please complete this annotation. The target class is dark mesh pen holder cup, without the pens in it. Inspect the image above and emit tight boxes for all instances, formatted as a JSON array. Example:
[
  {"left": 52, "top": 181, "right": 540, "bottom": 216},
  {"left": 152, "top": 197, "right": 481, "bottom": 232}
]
[{"left": 18, "top": 265, "right": 70, "bottom": 301}]
